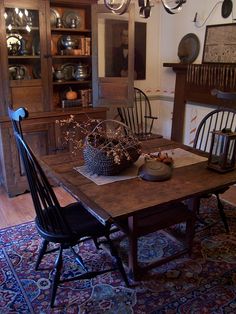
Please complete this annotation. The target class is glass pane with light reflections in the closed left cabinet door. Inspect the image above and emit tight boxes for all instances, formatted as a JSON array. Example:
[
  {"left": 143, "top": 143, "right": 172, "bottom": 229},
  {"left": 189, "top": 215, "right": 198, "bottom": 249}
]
[{"left": 4, "top": 8, "right": 41, "bottom": 80}]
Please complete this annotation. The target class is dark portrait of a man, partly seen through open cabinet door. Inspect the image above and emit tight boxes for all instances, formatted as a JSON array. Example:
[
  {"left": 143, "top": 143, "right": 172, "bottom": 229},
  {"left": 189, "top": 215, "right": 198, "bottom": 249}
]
[{"left": 105, "top": 20, "right": 146, "bottom": 80}]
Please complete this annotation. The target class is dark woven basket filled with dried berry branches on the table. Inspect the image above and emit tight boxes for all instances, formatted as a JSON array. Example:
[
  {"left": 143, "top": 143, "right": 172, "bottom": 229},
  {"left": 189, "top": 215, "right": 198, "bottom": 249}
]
[{"left": 57, "top": 115, "right": 141, "bottom": 175}]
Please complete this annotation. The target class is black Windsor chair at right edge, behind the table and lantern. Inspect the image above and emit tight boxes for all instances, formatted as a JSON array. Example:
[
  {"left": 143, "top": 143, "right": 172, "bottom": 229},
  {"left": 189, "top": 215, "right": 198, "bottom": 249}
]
[{"left": 193, "top": 90, "right": 236, "bottom": 232}]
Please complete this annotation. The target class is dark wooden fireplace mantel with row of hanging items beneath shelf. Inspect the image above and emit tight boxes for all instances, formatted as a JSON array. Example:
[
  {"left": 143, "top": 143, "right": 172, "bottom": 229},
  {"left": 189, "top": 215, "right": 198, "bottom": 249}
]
[{"left": 163, "top": 63, "right": 236, "bottom": 142}]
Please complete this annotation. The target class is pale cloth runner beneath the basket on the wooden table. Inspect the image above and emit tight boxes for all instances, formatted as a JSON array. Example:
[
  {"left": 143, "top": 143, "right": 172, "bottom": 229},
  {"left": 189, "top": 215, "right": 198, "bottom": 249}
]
[{"left": 74, "top": 148, "right": 207, "bottom": 185}]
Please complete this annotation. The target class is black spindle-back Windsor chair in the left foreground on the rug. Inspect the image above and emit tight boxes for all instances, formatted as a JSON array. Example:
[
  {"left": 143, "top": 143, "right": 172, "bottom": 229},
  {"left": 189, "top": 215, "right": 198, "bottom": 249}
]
[{"left": 8, "top": 108, "right": 129, "bottom": 307}]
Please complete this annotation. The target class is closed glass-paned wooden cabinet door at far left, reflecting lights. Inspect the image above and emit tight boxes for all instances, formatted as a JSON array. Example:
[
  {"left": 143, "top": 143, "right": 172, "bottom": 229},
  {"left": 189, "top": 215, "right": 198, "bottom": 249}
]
[{"left": 1, "top": 0, "right": 47, "bottom": 112}]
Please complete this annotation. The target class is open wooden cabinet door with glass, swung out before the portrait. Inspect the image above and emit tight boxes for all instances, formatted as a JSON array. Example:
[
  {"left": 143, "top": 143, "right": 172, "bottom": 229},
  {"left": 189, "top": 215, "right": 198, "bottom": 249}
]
[{"left": 92, "top": 4, "right": 134, "bottom": 106}]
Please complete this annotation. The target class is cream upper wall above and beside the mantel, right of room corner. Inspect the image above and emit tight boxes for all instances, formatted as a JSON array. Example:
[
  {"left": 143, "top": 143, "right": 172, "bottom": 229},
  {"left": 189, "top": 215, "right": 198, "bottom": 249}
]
[{"left": 159, "top": 0, "right": 236, "bottom": 92}]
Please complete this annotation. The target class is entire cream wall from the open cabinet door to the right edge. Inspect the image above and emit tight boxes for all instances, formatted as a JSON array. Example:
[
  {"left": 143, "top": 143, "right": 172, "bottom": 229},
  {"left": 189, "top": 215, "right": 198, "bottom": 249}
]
[{"left": 135, "top": 0, "right": 236, "bottom": 144}]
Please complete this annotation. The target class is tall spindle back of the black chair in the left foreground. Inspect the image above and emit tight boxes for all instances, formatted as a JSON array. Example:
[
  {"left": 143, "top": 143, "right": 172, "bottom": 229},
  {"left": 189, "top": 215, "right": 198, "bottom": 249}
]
[{"left": 8, "top": 108, "right": 71, "bottom": 237}]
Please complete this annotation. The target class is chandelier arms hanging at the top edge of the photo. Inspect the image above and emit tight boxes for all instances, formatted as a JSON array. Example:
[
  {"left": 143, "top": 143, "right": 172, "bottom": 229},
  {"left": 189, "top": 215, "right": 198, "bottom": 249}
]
[{"left": 104, "top": 0, "right": 187, "bottom": 18}]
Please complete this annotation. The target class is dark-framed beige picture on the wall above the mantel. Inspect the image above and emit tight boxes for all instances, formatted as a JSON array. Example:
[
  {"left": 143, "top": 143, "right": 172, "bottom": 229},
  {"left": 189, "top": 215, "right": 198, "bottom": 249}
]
[{"left": 202, "top": 23, "right": 236, "bottom": 63}]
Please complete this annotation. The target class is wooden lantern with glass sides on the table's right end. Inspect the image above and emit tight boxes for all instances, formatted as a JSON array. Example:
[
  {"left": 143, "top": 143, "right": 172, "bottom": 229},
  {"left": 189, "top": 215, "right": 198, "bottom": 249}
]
[{"left": 208, "top": 129, "right": 236, "bottom": 172}]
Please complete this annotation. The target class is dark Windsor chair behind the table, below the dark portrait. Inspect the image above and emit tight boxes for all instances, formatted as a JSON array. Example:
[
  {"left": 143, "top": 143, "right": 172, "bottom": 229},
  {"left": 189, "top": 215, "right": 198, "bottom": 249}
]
[{"left": 118, "top": 87, "right": 162, "bottom": 141}]
